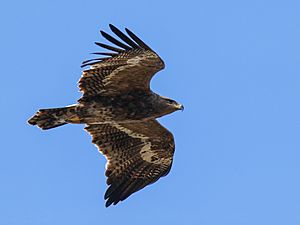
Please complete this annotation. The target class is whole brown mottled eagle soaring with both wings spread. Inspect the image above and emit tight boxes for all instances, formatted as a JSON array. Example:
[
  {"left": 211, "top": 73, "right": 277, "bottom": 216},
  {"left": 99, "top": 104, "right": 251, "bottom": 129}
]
[{"left": 28, "top": 24, "right": 183, "bottom": 207}]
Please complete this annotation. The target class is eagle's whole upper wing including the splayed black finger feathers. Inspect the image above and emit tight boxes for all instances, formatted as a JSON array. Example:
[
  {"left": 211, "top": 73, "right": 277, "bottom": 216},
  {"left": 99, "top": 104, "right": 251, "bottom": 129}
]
[{"left": 79, "top": 24, "right": 164, "bottom": 99}]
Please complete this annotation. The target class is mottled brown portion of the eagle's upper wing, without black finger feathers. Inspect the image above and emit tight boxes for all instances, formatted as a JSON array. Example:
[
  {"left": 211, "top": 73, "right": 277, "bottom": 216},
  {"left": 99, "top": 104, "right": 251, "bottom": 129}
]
[{"left": 79, "top": 49, "right": 164, "bottom": 96}]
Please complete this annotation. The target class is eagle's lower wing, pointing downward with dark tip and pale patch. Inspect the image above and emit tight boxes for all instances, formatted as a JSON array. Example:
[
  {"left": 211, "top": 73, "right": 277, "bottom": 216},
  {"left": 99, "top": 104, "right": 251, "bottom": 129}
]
[{"left": 85, "top": 120, "right": 175, "bottom": 207}]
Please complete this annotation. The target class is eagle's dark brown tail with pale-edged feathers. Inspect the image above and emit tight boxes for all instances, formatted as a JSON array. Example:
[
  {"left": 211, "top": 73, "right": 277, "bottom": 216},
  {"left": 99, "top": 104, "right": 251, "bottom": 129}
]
[{"left": 28, "top": 106, "right": 80, "bottom": 130}]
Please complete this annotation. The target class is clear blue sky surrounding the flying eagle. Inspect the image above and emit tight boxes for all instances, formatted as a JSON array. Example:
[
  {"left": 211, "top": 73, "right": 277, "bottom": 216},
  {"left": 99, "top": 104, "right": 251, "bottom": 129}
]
[{"left": 0, "top": 0, "right": 300, "bottom": 225}]
